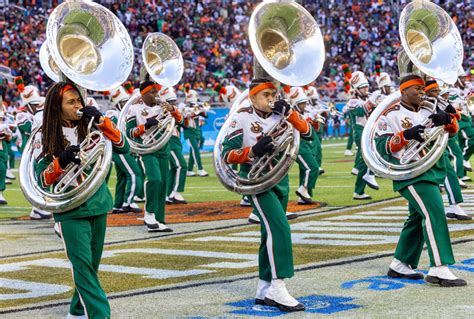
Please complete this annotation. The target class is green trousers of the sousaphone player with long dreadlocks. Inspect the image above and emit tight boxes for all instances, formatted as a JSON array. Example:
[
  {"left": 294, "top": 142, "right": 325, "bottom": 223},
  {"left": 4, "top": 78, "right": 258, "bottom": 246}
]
[{"left": 58, "top": 214, "right": 110, "bottom": 318}]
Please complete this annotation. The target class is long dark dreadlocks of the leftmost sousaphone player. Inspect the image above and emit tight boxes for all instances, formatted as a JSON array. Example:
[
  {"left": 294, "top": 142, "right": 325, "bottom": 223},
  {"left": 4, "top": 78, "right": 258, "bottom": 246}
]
[{"left": 41, "top": 82, "right": 88, "bottom": 156}]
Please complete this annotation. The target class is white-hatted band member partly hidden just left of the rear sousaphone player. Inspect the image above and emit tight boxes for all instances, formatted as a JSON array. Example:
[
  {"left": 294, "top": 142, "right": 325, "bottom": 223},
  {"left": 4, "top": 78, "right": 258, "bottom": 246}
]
[{"left": 106, "top": 86, "right": 143, "bottom": 214}]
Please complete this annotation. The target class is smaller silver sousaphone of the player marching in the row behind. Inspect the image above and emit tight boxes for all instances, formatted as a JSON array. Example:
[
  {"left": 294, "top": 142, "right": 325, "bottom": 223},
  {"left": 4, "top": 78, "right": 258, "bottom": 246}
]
[{"left": 118, "top": 32, "right": 184, "bottom": 154}]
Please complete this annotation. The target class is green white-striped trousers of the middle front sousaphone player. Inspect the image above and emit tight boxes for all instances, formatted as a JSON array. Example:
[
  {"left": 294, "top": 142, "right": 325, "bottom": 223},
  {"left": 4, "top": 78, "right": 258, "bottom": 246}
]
[{"left": 249, "top": 177, "right": 294, "bottom": 281}]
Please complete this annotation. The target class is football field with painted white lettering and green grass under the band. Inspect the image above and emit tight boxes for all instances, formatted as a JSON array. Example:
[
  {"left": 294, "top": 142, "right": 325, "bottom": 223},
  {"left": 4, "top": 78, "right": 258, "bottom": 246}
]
[{"left": 0, "top": 140, "right": 474, "bottom": 318}]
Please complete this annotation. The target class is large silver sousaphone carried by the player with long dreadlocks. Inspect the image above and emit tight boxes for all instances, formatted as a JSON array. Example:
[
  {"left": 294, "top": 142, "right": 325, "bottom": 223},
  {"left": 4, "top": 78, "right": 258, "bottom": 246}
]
[{"left": 19, "top": 2, "right": 133, "bottom": 213}]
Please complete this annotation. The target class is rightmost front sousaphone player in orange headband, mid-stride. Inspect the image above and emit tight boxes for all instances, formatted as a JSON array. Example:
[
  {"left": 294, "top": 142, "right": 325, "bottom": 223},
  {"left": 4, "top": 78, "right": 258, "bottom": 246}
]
[{"left": 376, "top": 75, "right": 466, "bottom": 287}]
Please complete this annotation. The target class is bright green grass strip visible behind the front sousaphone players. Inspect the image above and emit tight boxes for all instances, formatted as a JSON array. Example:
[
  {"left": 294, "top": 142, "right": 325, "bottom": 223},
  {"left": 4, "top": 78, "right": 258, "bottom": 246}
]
[{"left": 0, "top": 139, "right": 452, "bottom": 219}]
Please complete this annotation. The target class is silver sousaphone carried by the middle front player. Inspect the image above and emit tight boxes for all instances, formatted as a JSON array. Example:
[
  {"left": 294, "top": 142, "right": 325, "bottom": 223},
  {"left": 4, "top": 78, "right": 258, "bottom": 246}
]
[{"left": 214, "top": 1, "right": 324, "bottom": 195}]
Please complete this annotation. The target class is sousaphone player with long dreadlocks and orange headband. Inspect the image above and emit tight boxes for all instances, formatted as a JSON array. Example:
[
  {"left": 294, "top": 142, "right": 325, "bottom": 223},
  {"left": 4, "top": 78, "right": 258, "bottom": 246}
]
[{"left": 35, "top": 82, "right": 128, "bottom": 318}]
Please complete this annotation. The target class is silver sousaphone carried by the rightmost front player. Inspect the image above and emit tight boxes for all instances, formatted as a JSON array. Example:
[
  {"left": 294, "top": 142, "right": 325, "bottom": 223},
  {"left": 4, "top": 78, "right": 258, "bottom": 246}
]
[{"left": 361, "top": 1, "right": 463, "bottom": 181}]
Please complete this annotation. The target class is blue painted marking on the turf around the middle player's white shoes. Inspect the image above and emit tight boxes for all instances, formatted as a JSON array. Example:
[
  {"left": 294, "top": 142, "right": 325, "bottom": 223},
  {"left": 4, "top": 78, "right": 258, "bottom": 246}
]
[{"left": 225, "top": 295, "right": 362, "bottom": 317}]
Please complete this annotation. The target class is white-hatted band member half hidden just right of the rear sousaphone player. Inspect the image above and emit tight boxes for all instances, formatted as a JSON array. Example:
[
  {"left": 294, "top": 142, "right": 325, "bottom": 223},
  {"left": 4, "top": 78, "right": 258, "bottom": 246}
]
[{"left": 160, "top": 87, "right": 188, "bottom": 204}]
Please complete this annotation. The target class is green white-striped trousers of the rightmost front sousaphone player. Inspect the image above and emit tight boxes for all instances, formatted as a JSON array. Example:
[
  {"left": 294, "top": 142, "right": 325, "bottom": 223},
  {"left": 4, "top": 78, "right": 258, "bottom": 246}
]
[{"left": 395, "top": 181, "right": 454, "bottom": 268}]
